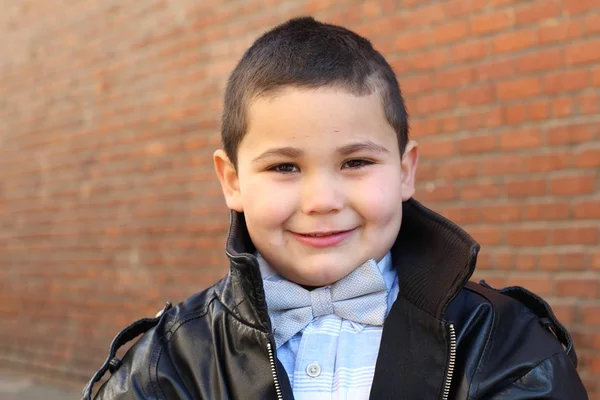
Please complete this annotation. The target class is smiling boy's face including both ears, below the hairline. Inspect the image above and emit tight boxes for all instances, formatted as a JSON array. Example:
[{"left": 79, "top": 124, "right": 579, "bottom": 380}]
[{"left": 214, "top": 88, "right": 417, "bottom": 286}]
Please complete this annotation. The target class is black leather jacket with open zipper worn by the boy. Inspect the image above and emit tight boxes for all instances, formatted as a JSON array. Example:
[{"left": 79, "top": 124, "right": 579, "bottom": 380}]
[{"left": 83, "top": 200, "right": 587, "bottom": 400}]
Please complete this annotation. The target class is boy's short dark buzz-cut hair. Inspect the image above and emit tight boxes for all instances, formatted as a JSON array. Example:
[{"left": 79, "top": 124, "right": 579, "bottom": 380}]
[{"left": 221, "top": 17, "right": 408, "bottom": 168}]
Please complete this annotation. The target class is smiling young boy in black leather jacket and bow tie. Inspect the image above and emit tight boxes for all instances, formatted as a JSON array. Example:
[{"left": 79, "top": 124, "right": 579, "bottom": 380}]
[{"left": 83, "top": 18, "right": 587, "bottom": 400}]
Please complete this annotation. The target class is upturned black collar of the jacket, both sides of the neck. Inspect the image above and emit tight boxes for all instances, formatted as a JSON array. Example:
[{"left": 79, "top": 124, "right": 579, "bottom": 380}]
[{"left": 221, "top": 199, "right": 479, "bottom": 332}]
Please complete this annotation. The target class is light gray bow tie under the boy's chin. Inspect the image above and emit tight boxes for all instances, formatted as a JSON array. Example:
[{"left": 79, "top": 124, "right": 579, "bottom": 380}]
[{"left": 263, "top": 260, "right": 387, "bottom": 348}]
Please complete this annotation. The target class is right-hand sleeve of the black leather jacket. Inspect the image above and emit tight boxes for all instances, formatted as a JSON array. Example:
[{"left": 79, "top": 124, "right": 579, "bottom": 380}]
[{"left": 470, "top": 282, "right": 588, "bottom": 400}]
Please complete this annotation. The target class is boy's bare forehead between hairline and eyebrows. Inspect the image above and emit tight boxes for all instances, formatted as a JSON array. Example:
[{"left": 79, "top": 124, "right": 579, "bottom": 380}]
[{"left": 239, "top": 87, "right": 397, "bottom": 152}]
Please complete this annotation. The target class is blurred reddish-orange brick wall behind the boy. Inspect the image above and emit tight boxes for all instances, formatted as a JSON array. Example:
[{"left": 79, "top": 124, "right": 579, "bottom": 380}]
[{"left": 0, "top": 0, "right": 600, "bottom": 398}]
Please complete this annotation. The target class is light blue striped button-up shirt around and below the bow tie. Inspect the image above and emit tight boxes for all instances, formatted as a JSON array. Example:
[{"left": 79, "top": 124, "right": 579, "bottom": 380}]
[{"left": 258, "top": 253, "right": 398, "bottom": 400}]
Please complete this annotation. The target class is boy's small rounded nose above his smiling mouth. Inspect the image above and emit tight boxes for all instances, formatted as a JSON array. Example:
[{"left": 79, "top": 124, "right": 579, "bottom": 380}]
[{"left": 301, "top": 173, "right": 345, "bottom": 214}]
